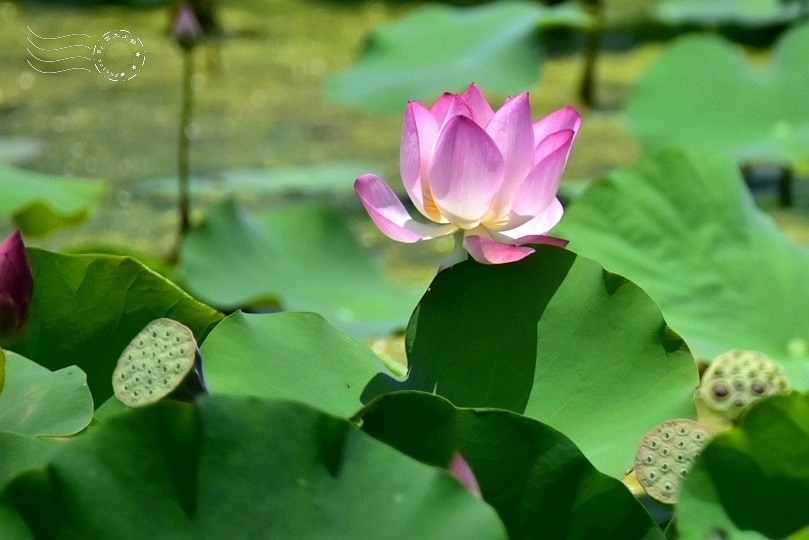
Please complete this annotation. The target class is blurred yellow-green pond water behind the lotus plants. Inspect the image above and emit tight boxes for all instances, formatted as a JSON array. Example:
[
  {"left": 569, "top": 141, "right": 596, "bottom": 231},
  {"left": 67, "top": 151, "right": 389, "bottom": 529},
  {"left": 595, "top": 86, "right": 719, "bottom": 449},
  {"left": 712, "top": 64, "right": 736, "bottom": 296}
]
[{"left": 0, "top": 0, "right": 657, "bottom": 256}]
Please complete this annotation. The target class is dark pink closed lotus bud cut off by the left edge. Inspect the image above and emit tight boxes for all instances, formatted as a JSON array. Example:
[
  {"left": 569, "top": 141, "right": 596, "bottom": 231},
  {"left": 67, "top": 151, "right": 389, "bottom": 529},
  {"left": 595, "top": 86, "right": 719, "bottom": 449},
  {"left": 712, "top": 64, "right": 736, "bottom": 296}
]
[{"left": 0, "top": 231, "right": 34, "bottom": 339}]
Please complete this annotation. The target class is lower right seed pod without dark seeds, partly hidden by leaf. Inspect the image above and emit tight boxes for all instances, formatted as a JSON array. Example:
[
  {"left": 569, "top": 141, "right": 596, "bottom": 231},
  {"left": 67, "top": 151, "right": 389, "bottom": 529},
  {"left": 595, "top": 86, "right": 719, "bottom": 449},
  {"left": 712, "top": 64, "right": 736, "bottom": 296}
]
[{"left": 635, "top": 418, "right": 713, "bottom": 504}]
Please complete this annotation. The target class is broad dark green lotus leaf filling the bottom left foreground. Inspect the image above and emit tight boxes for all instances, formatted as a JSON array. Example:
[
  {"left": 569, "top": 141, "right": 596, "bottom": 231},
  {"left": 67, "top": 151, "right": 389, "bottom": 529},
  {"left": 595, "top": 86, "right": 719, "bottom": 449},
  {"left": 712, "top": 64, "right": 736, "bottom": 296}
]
[{"left": 3, "top": 396, "right": 506, "bottom": 539}]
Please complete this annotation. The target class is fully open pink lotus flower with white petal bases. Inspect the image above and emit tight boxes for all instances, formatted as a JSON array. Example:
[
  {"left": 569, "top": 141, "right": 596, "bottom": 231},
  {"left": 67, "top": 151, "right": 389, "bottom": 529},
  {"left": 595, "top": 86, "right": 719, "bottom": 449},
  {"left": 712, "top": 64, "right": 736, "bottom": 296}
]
[{"left": 354, "top": 83, "right": 581, "bottom": 268}]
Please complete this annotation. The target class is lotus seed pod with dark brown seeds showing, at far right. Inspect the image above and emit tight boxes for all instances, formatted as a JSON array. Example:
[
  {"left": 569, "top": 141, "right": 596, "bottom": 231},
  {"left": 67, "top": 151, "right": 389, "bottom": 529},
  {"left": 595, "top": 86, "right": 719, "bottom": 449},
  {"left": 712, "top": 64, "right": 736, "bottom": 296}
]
[{"left": 697, "top": 350, "right": 789, "bottom": 421}]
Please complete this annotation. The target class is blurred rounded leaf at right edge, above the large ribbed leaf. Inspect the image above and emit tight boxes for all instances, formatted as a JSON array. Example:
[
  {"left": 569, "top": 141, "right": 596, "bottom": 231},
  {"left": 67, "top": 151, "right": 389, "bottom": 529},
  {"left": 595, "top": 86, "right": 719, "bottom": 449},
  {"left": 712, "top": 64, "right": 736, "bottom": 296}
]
[{"left": 626, "top": 24, "right": 809, "bottom": 168}]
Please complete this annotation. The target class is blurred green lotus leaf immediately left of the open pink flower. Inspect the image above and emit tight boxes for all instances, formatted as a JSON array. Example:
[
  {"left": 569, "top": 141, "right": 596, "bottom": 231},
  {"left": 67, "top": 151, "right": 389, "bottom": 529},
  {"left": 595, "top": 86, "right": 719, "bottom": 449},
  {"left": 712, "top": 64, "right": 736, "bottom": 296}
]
[{"left": 176, "top": 201, "right": 421, "bottom": 336}]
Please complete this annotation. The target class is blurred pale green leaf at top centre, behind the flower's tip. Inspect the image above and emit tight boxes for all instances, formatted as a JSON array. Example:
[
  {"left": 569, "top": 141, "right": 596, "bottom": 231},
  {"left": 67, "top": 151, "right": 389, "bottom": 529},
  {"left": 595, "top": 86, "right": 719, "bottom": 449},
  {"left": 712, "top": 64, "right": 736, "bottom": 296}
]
[{"left": 325, "top": 1, "right": 589, "bottom": 113}]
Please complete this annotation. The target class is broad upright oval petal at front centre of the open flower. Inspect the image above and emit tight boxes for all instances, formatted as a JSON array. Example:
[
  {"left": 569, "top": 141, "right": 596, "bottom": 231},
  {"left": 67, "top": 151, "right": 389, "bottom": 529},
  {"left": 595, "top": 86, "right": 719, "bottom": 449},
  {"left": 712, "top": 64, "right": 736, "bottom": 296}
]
[{"left": 430, "top": 116, "right": 503, "bottom": 228}]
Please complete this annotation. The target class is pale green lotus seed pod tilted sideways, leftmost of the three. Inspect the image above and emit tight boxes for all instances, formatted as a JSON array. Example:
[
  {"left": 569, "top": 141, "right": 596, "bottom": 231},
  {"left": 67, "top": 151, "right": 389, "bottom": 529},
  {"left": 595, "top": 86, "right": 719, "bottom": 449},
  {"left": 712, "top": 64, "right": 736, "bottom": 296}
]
[{"left": 112, "top": 319, "right": 207, "bottom": 407}]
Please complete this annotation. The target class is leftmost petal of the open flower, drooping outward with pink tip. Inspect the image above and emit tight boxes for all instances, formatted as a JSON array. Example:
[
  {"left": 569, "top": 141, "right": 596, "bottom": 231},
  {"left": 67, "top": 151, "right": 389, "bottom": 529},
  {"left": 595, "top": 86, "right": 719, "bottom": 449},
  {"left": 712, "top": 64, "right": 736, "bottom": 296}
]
[{"left": 354, "top": 174, "right": 457, "bottom": 243}]
